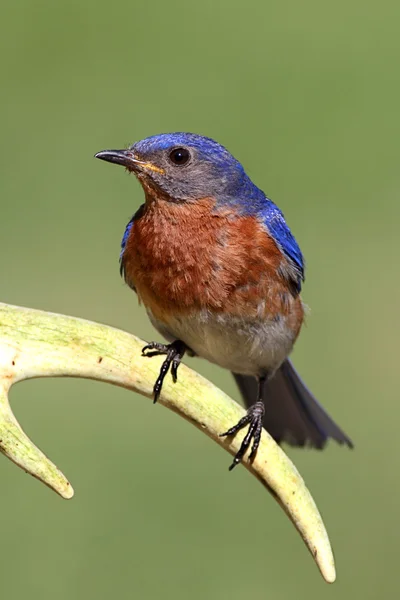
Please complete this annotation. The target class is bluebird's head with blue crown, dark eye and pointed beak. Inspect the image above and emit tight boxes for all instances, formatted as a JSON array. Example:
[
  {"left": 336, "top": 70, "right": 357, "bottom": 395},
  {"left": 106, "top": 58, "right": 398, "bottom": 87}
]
[{"left": 96, "top": 133, "right": 257, "bottom": 202}]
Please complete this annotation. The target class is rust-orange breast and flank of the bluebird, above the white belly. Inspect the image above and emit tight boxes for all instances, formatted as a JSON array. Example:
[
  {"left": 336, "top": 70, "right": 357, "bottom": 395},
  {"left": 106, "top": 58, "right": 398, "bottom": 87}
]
[{"left": 123, "top": 198, "right": 303, "bottom": 338}]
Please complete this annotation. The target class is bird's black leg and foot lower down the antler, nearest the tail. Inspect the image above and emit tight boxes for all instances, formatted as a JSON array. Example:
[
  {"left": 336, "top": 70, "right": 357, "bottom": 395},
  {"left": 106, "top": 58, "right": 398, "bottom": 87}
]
[{"left": 220, "top": 377, "right": 266, "bottom": 471}]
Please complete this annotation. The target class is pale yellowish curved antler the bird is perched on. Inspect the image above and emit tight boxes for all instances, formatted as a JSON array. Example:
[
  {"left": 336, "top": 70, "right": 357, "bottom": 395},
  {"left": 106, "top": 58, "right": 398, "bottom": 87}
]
[{"left": 0, "top": 303, "right": 335, "bottom": 582}]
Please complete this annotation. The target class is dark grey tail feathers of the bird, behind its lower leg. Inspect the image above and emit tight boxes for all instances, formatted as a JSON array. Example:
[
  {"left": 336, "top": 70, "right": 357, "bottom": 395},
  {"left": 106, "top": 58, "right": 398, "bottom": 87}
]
[{"left": 233, "top": 360, "right": 353, "bottom": 449}]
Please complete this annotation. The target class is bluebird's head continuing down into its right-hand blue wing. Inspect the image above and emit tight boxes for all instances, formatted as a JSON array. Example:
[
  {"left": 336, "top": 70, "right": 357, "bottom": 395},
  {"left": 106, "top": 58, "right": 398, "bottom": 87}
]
[{"left": 96, "top": 133, "right": 304, "bottom": 285}]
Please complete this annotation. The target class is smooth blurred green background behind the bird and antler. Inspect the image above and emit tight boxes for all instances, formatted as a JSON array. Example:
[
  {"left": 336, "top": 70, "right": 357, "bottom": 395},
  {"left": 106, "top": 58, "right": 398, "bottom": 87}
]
[{"left": 0, "top": 0, "right": 400, "bottom": 600}]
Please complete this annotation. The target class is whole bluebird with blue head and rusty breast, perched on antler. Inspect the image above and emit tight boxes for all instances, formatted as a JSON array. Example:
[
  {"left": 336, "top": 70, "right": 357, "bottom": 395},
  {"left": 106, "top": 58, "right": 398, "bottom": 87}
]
[{"left": 95, "top": 132, "right": 353, "bottom": 470}]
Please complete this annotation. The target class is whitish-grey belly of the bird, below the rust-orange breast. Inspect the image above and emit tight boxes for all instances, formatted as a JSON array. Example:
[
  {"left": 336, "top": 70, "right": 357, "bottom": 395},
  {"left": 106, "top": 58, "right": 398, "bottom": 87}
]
[{"left": 149, "top": 310, "right": 295, "bottom": 375}]
